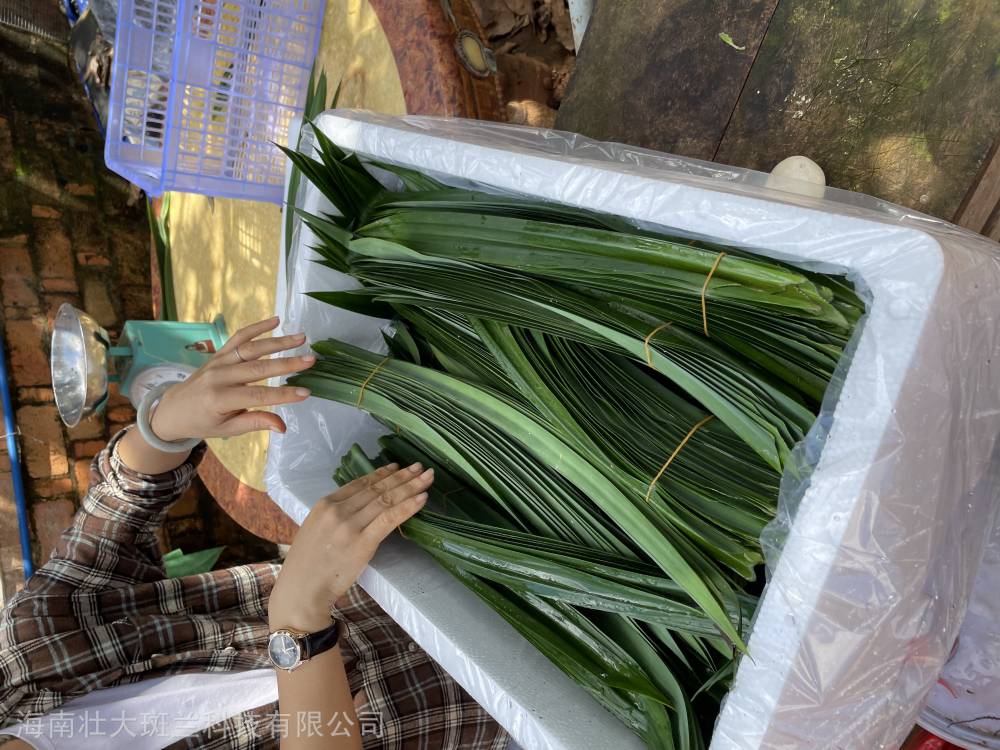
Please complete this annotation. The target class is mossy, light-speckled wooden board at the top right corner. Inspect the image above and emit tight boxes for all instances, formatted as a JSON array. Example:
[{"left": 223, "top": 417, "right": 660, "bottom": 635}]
[{"left": 716, "top": 0, "right": 1000, "bottom": 218}]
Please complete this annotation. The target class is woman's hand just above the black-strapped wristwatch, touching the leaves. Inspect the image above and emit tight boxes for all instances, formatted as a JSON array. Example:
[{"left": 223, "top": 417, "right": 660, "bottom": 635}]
[{"left": 268, "top": 464, "right": 434, "bottom": 633}]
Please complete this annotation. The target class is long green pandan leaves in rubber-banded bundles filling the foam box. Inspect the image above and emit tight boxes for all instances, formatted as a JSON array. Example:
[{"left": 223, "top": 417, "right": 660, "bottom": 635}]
[{"left": 287, "top": 128, "right": 864, "bottom": 750}]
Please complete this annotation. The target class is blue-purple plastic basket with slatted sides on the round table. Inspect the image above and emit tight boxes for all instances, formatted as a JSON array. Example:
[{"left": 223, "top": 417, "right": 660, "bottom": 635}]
[{"left": 104, "top": 0, "right": 325, "bottom": 203}]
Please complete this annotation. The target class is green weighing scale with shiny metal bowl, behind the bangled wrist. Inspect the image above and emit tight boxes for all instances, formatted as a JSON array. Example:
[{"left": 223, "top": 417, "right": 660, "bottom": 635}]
[{"left": 52, "top": 303, "right": 228, "bottom": 427}]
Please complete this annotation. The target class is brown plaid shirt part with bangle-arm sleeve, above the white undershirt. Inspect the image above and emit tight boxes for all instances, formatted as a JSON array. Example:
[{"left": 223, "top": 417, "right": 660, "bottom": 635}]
[{"left": 0, "top": 431, "right": 278, "bottom": 725}]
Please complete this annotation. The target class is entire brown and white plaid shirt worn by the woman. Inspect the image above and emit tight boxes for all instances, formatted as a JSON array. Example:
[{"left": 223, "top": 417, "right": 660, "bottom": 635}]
[{"left": 0, "top": 431, "right": 508, "bottom": 750}]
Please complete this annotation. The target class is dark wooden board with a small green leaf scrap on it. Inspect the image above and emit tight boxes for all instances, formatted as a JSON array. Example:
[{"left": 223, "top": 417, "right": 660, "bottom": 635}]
[{"left": 556, "top": 0, "right": 778, "bottom": 159}]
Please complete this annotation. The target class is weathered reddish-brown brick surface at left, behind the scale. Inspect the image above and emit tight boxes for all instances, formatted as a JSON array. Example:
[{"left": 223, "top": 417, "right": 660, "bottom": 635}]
[{"left": 0, "top": 20, "right": 273, "bottom": 596}]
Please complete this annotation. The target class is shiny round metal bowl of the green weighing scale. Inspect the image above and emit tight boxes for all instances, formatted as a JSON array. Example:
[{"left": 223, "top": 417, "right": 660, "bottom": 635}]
[{"left": 52, "top": 303, "right": 111, "bottom": 427}]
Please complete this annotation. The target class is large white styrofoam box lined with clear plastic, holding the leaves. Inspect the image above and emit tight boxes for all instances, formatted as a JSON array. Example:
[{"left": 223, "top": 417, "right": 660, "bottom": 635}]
[{"left": 266, "top": 111, "right": 1000, "bottom": 750}]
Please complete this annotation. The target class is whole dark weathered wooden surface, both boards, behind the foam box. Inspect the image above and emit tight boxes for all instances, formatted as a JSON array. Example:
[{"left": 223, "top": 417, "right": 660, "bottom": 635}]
[{"left": 557, "top": 0, "right": 1000, "bottom": 223}]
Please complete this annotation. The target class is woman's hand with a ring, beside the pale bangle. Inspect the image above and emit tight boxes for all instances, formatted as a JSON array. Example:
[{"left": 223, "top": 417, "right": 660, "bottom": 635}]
[{"left": 150, "top": 317, "right": 316, "bottom": 441}]
